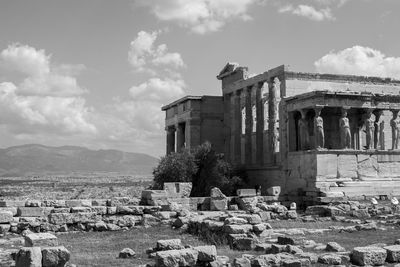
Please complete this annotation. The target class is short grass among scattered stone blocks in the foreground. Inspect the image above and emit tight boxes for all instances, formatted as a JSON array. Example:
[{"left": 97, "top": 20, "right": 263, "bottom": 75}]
[{"left": 58, "top": 221, "right": 400, "bottom": 266}]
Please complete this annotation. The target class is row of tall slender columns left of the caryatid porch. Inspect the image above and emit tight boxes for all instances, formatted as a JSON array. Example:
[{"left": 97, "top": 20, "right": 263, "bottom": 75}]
[{"left": 224, "top": 78, "right": 280, "bottom": 165}]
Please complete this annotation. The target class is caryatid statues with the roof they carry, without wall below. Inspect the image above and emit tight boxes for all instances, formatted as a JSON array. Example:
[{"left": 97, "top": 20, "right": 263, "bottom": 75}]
[{"left": 285, "top": 91, "right": 400, "bottom": 151}]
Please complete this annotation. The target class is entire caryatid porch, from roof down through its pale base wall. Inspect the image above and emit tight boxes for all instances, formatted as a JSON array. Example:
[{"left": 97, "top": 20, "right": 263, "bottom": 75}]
[{"left": 284, "top": 91, "right": 400, "bottom": 197}]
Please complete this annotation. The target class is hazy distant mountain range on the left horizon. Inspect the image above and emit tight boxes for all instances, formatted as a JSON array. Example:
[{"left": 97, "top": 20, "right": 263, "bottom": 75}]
[{"left": 0, "top": 144, "right": 158, "bottom": 177}]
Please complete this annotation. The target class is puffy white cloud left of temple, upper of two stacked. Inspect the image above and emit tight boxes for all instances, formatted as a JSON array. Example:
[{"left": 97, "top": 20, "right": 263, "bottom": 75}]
[{"left": 128, "top": 31, "right": 185, "bottom": 74}]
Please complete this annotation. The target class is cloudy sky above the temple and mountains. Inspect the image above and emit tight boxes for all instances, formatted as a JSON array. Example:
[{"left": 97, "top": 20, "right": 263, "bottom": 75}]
[{"left": 0, "top": 0, "right": 400, "bottom": 156}]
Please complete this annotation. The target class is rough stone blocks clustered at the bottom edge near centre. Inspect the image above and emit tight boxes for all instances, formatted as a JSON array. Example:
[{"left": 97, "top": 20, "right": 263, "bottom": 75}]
[{"left": 147, "top": 239, "right": 229, "bottom": 267}]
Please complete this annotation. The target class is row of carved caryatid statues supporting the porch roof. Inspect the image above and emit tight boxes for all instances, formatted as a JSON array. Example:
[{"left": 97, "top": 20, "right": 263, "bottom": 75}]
[{"left": 298, "top": 107, "right": 400, "bottom": 153}]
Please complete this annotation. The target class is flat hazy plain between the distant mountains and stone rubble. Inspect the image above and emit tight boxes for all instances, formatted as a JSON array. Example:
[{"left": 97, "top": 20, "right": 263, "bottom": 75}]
[{"left": 0, "top": 173, "right": 152, "bottom": 200}]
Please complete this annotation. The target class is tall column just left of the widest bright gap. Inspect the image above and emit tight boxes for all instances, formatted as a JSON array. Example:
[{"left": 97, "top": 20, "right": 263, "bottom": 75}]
[{"left": 256, "top": 82, "right": 264, "bottom": 165}]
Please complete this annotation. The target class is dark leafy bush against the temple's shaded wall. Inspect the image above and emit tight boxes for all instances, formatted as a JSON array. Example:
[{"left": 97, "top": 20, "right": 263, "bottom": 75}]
[{"left": 152, "top": 150, "right": 197, "bottom": 189}]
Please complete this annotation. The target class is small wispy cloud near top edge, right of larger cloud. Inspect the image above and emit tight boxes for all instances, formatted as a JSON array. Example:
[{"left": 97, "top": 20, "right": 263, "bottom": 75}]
[{"left": 279, "top": 5, "right": 335, "bottom": 21}]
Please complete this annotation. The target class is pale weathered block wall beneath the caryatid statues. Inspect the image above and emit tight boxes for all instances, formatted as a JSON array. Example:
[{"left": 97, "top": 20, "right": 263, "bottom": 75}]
[{"left": 284, "top": 150, "right": 400, "bottom": 200}]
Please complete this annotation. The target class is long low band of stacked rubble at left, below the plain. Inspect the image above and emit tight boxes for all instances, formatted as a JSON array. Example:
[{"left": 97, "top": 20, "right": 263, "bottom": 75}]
[{"left": 0, "top": 197, "right": 171, "bottom": 235}]
